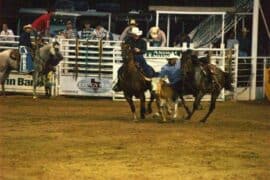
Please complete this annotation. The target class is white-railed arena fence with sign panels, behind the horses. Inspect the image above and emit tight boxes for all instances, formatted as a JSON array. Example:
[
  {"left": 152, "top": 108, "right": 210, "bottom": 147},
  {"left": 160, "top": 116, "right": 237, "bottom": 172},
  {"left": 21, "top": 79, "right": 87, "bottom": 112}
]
[{"left": 0, "top": 36, "right": 269, "bottom": 100}]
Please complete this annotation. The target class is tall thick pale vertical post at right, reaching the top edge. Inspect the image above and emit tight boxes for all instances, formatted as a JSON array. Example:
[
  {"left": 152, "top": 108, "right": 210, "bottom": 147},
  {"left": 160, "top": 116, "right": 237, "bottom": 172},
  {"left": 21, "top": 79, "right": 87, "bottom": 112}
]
[{"left": 250, "top": 0, "right": 259, "bottom": 100}]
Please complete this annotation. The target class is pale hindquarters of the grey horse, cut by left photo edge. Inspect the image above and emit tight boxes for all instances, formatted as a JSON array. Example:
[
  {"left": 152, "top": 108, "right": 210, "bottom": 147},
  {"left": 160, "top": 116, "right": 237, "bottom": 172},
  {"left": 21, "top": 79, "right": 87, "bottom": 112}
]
[{"left": 0, "top": 49, "right": 20, "bottom": 95}]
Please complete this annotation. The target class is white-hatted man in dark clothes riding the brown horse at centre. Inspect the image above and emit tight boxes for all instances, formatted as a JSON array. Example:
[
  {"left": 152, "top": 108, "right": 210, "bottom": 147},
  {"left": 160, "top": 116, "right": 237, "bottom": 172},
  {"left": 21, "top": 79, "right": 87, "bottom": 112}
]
[{"left": 113, "top": 27, "right": 155, "bottom": 92}]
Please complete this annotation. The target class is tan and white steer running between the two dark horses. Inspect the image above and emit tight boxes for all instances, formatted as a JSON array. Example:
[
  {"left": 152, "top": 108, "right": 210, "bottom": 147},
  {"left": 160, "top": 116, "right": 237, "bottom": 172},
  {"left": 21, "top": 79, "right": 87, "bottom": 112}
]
[{"left": 152, "top": 78, "right": 178, "bottom": 122}]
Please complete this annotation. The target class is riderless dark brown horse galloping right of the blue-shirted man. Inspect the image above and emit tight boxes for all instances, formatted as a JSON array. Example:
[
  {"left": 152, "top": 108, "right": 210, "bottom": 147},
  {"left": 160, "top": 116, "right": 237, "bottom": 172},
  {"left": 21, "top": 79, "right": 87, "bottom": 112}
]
[{"left": 180, "top": 51, "right": 233, "bottom": 122}]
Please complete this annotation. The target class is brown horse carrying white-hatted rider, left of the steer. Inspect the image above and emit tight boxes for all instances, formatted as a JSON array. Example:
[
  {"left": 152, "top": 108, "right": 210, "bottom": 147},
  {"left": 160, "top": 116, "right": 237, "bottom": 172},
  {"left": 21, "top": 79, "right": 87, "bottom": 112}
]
[{"left": 118, "top": 43, "right": 154, "bottom": 121}]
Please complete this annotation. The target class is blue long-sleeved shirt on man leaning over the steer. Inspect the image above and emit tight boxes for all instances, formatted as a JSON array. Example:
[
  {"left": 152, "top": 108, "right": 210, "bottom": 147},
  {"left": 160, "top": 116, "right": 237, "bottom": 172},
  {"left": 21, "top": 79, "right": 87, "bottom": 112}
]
[{"left": 159, "top": 60, "right": 181, "bottom": 84}]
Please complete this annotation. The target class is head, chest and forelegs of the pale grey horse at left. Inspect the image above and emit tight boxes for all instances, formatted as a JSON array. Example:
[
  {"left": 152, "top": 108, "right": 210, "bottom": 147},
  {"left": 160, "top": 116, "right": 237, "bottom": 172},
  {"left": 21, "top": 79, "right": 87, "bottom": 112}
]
[{"left": 32, "top": 42, "right": 63, "bottom": 99}]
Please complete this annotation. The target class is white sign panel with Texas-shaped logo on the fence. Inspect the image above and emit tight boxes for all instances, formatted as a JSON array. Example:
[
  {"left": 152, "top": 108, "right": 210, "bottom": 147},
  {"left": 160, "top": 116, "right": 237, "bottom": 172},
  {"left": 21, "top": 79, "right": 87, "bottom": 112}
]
[{"left": 59, "top": 76, "right": 112, "bottom": 97}]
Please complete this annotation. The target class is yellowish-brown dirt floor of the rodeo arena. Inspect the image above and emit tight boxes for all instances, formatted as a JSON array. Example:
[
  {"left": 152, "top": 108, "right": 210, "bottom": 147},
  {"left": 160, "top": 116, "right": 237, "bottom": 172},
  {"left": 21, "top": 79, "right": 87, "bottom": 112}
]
[{"left": 0, "top": 95, "right": 270, "bottom": 180}]
